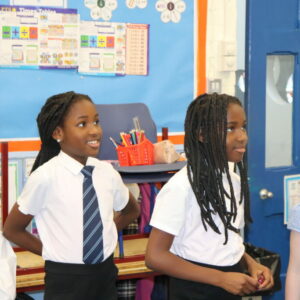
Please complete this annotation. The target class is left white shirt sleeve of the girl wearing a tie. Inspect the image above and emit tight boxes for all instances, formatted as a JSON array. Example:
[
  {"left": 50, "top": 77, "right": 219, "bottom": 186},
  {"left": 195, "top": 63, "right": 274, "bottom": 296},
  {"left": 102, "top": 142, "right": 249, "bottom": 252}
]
[{"left": 17, "top": 169, "right": 48, "bottom": 216}]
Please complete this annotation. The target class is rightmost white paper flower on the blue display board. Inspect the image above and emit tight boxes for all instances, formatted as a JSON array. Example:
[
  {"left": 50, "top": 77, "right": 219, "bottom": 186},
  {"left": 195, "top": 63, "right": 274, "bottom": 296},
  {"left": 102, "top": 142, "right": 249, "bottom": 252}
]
[{"left": 155, "top": 0, "right": 186, "bottom": 23}]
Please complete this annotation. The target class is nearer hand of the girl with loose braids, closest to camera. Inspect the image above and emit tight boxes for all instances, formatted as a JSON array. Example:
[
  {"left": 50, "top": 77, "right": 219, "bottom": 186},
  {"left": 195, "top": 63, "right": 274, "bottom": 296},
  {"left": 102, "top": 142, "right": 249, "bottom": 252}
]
[{"left": 220, "top": 272, "right": 259, "bottom": 296}]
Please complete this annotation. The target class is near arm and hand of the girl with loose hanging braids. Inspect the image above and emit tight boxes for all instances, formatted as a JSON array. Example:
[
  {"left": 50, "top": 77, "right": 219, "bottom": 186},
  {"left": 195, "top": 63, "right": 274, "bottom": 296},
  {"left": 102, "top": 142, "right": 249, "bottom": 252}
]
[{"left": 145, "top": 227, "right": 258, "bottom": 295}]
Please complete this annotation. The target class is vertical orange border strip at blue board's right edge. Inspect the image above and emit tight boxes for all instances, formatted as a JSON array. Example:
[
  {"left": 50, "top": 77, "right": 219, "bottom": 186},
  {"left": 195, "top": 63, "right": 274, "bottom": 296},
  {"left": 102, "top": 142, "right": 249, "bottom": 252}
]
[{"left": 197, "top": 0, "right": 207, "bottom": 95}]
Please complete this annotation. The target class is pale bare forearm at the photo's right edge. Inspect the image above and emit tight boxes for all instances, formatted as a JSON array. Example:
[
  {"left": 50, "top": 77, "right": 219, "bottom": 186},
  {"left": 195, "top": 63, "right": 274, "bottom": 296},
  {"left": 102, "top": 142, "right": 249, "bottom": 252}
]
[{"left": 285, "top": 230, "right": 300, "bottom": 300}]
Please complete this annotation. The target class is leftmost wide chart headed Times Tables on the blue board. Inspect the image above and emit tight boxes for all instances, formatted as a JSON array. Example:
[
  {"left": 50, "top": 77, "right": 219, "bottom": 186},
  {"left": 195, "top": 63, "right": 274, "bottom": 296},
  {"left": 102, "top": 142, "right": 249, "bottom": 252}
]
[{"left": 0, "top": 5, "right": 79, "bottom": 69}]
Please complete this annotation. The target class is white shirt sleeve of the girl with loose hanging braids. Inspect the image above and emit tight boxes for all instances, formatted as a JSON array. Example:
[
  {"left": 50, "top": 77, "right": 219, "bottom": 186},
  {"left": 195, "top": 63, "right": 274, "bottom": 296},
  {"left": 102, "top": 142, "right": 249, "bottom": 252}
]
[{"left": 150, "top": 181, "right": 187, "bottom": 236}]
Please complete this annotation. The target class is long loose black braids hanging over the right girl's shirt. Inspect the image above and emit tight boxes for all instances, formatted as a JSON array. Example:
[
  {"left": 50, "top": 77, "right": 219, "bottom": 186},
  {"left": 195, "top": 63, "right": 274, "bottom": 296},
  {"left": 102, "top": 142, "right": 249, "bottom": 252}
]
[{"left": 184, "top": 93, "right": 252, "bottom": 244}]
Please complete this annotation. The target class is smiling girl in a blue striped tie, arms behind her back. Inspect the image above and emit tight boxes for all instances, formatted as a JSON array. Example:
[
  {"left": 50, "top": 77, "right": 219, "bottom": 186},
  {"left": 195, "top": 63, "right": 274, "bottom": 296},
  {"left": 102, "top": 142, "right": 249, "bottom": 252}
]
[{"left": 3, "top": 92, "right": 139, "bottom": 300}]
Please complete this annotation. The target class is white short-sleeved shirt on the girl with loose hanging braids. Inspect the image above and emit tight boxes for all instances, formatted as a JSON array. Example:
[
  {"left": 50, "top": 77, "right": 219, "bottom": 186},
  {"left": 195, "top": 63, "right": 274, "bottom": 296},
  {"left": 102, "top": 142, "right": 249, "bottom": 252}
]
[{"left": 150, "top": 167, "right": 245, "bottom": 266}]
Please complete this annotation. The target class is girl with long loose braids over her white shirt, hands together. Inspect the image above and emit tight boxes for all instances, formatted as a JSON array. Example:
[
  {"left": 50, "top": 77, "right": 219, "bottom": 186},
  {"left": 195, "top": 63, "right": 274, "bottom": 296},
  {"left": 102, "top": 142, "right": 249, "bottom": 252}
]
[{"left": 146, "top": 93, "right": 273, "bottom": 300}]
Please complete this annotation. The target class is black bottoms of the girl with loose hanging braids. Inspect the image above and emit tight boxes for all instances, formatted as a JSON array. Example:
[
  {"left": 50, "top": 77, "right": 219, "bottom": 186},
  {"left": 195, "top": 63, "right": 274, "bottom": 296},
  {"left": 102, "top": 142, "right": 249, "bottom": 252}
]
[{"left": 169, "top": 261, "right": 244, "bottom": 300}]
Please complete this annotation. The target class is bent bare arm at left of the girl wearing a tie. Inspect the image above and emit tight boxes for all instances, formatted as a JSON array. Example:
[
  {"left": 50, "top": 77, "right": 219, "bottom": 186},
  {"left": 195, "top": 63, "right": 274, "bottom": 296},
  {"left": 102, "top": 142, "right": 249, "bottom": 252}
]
[{"left": 3, "top": 203, "right": 42, "bottom": 255}]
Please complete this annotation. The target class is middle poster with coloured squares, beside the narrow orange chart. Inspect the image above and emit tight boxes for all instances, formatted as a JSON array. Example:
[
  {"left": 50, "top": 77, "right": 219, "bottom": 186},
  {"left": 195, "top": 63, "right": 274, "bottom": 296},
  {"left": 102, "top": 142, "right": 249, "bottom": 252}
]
[{"left": 78, "top": 21, "right": 126, "bottom": 76}]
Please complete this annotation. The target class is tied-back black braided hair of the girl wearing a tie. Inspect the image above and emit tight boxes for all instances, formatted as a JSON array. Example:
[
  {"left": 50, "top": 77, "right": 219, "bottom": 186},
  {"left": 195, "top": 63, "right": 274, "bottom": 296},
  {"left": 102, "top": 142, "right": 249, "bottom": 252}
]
[{"left": 31, "top": 92, "right": 92, "bottom": 172}]
